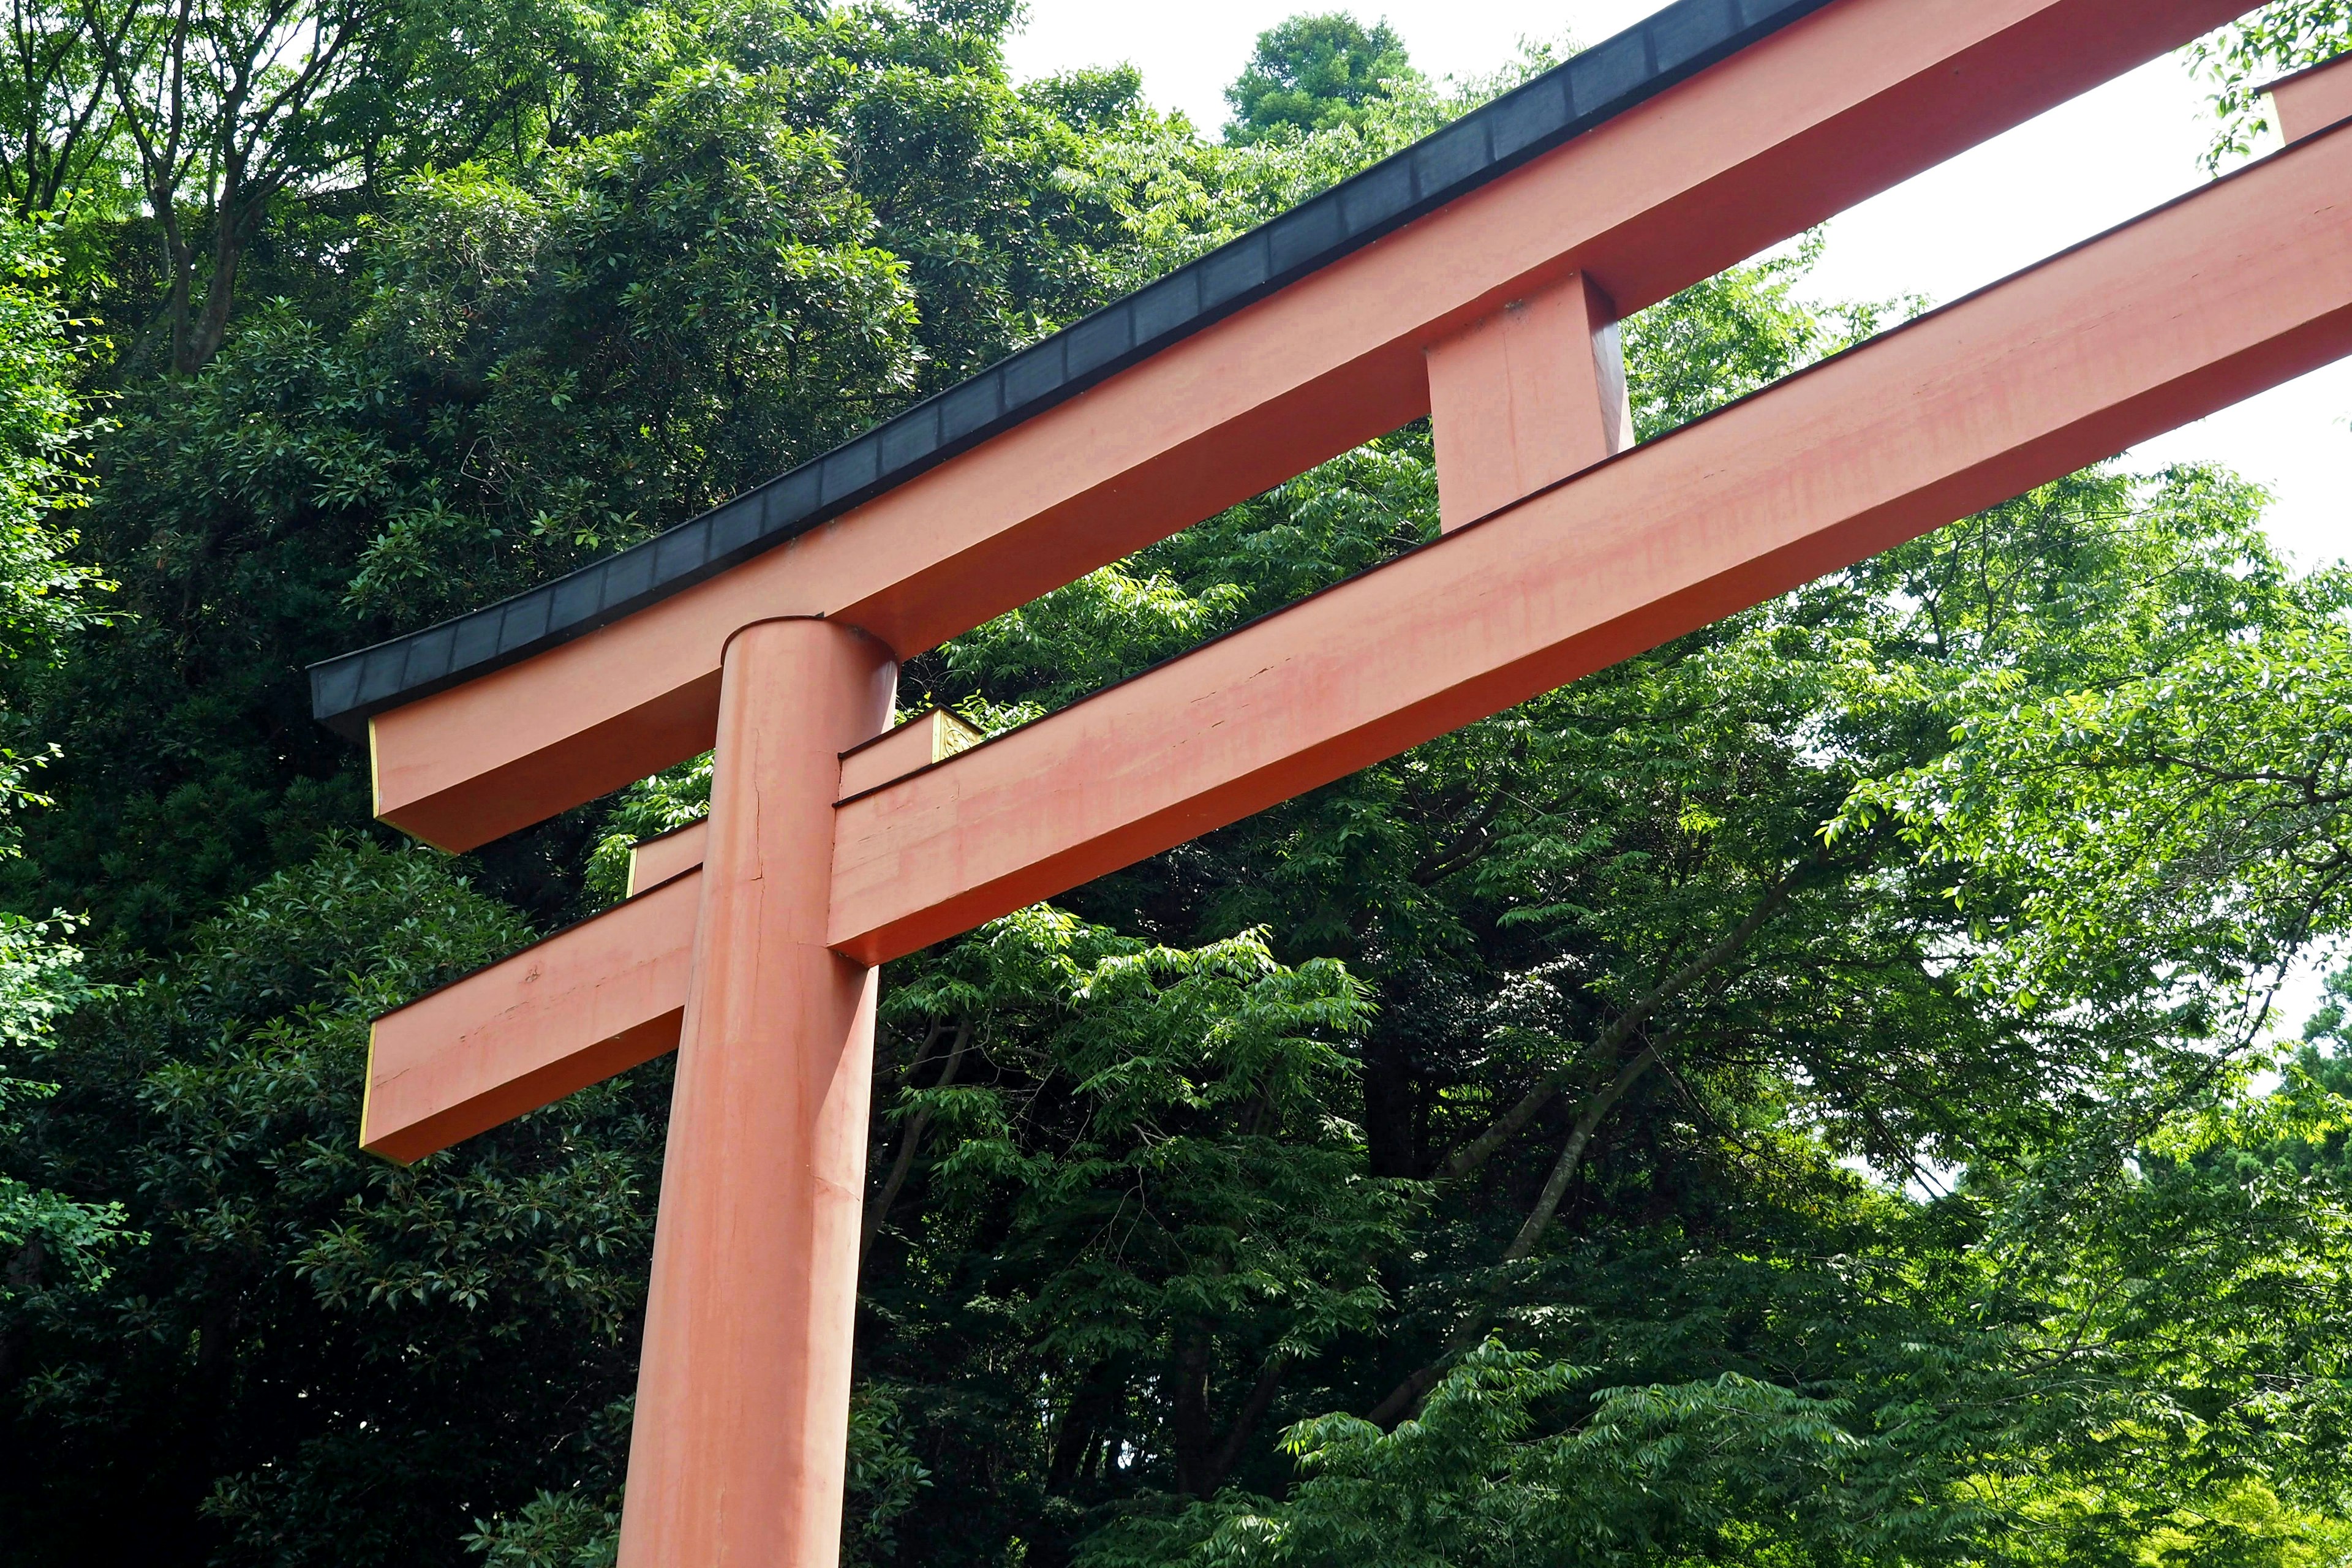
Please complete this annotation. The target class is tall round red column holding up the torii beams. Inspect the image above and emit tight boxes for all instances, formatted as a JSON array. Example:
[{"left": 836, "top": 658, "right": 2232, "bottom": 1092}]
[{"left": 621, "top": 620, "right": 896, "bottom": 1568}]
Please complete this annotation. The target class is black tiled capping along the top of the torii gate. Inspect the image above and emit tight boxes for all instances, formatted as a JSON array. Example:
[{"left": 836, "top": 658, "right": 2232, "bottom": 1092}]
[{"left": 311, "top": 0, "right": 1830, "bottom": 738}]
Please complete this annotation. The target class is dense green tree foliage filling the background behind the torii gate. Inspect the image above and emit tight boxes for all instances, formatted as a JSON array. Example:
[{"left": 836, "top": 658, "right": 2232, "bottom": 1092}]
[{"left": 0, "top": 0, "right": 2352, "bottom": 1568}]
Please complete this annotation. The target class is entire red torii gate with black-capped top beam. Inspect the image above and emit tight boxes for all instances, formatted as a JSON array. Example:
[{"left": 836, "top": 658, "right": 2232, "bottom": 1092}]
[{"left": 313, "top": 0, "right": 2352, "bottom": 1568}]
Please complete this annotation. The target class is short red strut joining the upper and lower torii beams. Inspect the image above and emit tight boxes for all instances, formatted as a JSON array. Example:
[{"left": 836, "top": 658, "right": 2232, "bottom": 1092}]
[{"left": 1428, "top": 273, "right": 1632, "bottom": 533}]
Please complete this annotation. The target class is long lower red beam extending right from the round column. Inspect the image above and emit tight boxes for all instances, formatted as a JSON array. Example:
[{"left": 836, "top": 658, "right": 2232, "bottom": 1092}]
[{"left": 828, "top": 129, "right": 2352, "bottom": 962}]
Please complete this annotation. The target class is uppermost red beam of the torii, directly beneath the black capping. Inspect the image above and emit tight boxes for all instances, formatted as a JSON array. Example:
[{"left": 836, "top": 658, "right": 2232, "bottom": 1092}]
[{"left": 372, "top": 0, "right": 2242, "bottom": 849}]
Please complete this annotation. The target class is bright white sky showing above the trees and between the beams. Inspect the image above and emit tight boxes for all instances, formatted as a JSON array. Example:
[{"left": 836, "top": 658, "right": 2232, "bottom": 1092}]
[{"left": 1009, "top": 0, "right": 2352, "bottom": 1023}]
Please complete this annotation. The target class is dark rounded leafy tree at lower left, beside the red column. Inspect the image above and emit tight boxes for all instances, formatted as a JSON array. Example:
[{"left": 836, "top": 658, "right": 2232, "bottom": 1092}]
[{"left": 5, "top": 846, "right": 663, "bottom": 1563}]
